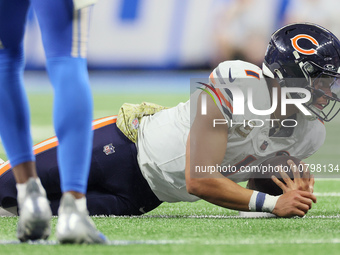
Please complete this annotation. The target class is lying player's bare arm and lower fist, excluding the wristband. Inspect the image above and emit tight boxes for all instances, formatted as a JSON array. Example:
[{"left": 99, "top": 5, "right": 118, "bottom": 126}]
[{"left": 185, "top": 93, "right": 315, "bottom": 217}]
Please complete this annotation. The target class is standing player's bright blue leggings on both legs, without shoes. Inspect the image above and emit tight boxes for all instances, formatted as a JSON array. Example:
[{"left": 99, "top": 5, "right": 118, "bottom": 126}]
[{"left": 0, "top": 0, "right": 93, "bottom": 193}]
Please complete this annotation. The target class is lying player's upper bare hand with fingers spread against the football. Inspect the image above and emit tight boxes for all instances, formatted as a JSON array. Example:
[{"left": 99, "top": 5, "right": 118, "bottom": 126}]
[{"left": 272, "top": 160, "right": 315, "bottom": 193}]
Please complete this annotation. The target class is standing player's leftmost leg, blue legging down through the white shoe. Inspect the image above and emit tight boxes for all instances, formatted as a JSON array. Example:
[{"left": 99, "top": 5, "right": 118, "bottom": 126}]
[{"left": 0, "top": 0, "right": 51, "bottom": 241}]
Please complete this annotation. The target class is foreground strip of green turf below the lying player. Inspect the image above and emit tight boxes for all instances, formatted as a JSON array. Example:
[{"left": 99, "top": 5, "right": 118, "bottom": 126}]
[{"left": 0, "top": 180, "right": 340, "bottom": 255}]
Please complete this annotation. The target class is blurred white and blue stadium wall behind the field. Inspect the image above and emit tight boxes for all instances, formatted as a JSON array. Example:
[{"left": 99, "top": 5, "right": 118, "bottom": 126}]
[{"left": 25, "top": 0, "right": 340, "bottom": 69}]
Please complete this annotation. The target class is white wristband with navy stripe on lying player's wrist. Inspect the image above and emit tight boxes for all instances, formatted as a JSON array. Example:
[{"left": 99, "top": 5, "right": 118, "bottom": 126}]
[{"left": 248, "top": 190, "right": 280, "bottom": 212}]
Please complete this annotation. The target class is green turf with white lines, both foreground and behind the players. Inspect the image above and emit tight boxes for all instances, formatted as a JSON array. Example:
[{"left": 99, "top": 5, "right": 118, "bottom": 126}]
[{"left": 0, "top": 72, "right": 340, "bottom": 255}]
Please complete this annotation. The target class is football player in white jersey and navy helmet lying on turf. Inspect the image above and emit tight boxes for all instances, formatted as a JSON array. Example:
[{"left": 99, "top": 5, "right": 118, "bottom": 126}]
[{"left": 0, "top": 24, "right": 340, "bottom": 217}]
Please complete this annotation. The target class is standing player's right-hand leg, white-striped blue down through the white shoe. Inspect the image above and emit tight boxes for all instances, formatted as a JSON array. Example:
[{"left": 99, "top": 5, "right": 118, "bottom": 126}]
[{"left": 32, "top": 0, "right": 105, "bottom": 243}]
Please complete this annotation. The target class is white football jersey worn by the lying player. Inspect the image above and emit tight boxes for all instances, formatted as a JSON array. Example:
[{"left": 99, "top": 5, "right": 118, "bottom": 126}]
[{"left": 137, "top": 61, "right": 326, "bottom": 202}]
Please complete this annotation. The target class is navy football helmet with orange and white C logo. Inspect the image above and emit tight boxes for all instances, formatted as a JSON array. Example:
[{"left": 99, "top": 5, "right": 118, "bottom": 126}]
[{"left": 263, "top": 23, "right": 340, "bottom": 121}]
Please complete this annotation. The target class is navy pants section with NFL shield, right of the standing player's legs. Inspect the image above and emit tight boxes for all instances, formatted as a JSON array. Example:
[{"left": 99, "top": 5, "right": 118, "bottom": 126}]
[{"left": 88, "top": 121, "right": 161, "bottom": 215}]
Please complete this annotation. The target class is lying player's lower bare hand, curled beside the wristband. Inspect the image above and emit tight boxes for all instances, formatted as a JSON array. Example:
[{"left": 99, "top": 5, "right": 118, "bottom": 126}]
[{"left": 272, "top": 190, "right": 316, "bottom": 218}]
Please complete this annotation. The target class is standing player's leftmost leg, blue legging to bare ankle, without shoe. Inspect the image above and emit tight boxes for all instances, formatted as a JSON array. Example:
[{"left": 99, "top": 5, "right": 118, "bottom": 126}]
[{"left": 0, "top": 0, "right": 35, "bottom": 183}]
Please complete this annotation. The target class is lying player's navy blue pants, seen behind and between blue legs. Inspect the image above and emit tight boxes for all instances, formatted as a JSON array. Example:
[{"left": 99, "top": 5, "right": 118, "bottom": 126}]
[{"left": 0, "top": 121, "right": 162, "bottom": 215}]
